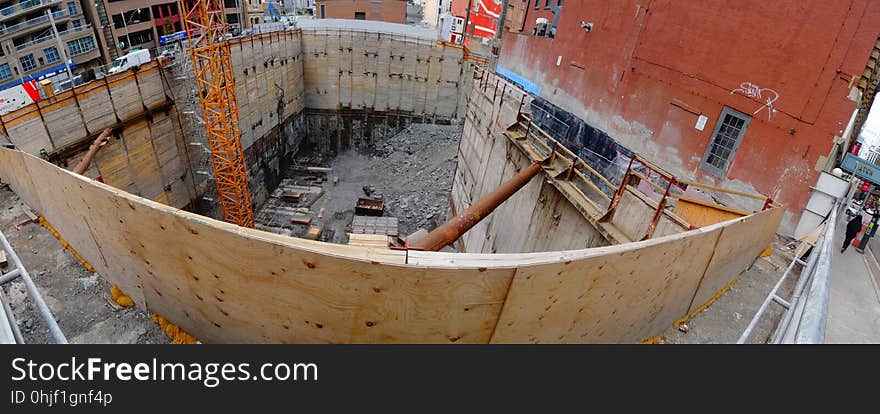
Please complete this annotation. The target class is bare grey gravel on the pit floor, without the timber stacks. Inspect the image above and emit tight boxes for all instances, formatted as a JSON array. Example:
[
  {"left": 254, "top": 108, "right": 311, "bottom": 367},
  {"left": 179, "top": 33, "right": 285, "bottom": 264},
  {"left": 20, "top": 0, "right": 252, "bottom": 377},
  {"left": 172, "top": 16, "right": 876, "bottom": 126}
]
[{"left": 287, "top": 124, "right": 461, "bottom": 244}]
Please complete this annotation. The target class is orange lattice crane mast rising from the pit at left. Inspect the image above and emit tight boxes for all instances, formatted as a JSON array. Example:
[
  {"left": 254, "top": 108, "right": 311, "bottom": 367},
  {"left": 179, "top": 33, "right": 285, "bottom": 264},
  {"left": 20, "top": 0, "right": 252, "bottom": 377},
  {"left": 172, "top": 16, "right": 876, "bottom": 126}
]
[{"left": 180, "top": 0, "right": 254, "bottom": 227}]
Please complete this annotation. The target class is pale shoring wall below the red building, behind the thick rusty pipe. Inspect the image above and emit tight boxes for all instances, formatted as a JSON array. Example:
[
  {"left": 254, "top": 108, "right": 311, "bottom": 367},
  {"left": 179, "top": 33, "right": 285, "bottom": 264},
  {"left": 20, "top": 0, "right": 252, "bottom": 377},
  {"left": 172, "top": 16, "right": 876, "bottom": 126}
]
[{"left": 450, "top": 71, "right": 696, "bottom": 253}]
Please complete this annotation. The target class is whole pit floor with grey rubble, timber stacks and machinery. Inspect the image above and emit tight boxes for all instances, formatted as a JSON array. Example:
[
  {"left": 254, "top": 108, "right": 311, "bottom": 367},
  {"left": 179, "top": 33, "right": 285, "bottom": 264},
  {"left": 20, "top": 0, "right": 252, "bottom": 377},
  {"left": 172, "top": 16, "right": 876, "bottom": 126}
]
[{"left": 255, "top": 124, "right": 461, "bottom": 247}]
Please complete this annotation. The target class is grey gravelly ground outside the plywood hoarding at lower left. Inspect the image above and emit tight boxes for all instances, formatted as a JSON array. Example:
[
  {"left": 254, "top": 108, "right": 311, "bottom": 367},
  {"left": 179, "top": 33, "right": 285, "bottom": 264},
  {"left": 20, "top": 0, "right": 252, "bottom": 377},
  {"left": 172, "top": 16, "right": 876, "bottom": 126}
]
[{"left": 0, "top": 184, "right": 168, "bottom": 344}]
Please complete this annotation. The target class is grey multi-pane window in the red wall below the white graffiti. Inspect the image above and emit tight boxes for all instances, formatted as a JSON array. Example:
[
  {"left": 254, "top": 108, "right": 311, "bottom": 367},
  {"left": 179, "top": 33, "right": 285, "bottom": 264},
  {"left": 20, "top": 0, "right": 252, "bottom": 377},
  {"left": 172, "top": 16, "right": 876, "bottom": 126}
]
[{"left": 701, "top": 107, "right": 752, "bottom": 178}]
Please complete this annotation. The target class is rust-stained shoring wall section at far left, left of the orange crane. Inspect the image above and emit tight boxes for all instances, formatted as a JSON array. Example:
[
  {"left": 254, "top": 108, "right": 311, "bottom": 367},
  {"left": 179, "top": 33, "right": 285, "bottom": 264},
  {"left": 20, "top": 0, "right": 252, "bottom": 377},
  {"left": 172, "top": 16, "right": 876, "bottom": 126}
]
[{"left": 0, "top": 61, "right": 195, "bottom": 207}]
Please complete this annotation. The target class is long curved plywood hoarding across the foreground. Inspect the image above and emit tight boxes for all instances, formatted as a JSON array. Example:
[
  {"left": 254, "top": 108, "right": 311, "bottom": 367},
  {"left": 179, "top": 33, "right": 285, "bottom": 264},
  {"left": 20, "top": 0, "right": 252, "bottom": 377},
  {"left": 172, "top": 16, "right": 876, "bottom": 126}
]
[{"left": 0, "top": 149, "right": 783, "bottom": 343}]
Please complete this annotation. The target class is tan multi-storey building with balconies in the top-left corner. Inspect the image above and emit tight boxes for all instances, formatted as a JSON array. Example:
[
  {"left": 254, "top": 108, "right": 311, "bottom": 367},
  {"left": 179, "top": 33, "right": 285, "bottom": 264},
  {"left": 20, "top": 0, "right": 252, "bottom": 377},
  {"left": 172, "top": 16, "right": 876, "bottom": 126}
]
[{"left": 0, "top": 0, "right": 104, "bottom": 89}]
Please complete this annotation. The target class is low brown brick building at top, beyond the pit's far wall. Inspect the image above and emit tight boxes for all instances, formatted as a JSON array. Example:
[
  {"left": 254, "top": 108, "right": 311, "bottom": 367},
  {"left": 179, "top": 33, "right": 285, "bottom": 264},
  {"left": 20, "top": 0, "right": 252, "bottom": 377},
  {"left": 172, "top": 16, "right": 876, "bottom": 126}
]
[{"left": 315, "top": 0, "right": 406, "bottom": 24}]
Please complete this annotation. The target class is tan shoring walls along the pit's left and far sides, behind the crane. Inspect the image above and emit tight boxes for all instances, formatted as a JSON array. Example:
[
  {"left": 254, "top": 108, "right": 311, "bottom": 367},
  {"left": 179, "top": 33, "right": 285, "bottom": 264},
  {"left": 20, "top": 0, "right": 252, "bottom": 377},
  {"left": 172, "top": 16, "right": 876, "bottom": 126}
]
[{"left": 0, "top": 22, "right": 470, "bottom": 213}]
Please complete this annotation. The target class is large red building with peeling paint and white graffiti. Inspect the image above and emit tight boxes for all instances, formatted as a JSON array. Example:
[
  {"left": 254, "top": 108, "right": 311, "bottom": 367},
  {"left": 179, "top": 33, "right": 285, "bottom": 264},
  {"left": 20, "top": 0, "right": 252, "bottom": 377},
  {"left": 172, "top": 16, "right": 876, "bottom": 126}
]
[{"left": 498, "top": 0, "right": 880, "bottom": 233}]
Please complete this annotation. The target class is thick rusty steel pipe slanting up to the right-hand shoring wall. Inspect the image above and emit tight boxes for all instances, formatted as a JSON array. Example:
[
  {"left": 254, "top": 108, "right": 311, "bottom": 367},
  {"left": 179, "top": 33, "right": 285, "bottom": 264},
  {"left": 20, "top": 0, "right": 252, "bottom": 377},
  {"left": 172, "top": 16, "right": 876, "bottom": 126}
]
[{"left": 409, "top": 163, "right": 541, "bottom": 251}]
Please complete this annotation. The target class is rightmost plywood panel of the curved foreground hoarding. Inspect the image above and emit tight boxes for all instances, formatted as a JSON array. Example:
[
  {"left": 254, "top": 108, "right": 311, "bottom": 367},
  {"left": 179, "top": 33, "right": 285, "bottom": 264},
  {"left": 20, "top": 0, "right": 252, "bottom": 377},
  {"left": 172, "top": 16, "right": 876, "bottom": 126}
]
[{"left": 688, "top": 208, "right": 785, "bottom": 312}]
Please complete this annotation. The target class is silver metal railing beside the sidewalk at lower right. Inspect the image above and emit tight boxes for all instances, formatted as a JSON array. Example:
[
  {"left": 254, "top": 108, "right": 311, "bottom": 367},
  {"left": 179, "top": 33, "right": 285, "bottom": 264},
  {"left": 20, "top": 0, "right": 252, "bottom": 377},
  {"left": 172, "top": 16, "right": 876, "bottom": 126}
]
[{"left": 737, "top": 200, "right": 842, "bottom": 344}]
